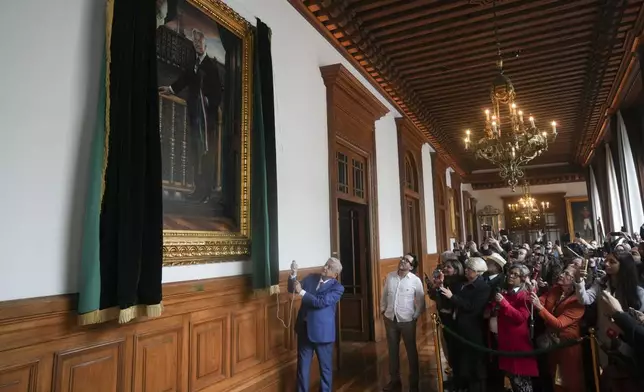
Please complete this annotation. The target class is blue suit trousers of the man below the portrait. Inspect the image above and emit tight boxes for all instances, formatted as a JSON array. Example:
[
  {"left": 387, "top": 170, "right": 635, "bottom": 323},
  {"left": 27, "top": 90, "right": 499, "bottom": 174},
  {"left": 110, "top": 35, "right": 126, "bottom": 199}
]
[{"left": 297, "top": 324, "right": 333, "bottom": 392}]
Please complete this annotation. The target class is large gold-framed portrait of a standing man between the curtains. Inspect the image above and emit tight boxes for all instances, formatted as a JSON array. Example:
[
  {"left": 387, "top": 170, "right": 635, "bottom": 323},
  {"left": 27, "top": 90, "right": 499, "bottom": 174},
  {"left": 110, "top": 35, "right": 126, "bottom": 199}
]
[{"left": 156, "top": 0, "right": 253, "bottom": 265}]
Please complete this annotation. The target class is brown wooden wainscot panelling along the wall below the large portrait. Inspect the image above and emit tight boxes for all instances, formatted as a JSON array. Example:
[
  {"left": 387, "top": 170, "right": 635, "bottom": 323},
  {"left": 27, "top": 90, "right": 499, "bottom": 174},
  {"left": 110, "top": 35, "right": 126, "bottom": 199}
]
[{"left": 0, "top": 268, "right": 317, "bottom": 392}]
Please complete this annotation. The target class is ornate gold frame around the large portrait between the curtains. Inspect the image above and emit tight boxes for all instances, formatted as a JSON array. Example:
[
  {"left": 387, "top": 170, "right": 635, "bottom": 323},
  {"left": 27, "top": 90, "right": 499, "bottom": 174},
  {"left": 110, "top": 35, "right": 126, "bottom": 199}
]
[{"left": 157, "top": 0, "right": 253, "bottom": 266}]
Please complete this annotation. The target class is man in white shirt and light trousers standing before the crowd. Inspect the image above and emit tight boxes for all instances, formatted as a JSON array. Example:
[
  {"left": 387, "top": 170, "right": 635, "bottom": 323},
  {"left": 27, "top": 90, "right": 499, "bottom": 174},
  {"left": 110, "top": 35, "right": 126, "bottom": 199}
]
[{"left": 380, "top": 254, "right": 425, "bottom": 392}]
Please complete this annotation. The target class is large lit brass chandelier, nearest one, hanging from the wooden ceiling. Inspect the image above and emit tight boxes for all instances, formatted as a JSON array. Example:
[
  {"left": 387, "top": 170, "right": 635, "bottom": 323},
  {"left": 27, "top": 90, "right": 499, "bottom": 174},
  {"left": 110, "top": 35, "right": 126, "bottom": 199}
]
[{"left": 465, "top": 2, "right": 557, "bottom": 192}]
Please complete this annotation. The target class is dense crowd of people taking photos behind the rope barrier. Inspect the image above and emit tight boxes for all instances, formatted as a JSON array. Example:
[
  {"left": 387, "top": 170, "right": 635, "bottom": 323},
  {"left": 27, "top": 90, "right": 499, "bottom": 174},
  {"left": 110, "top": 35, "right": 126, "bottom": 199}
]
[{"left": 425, "top": 226, "right": 644, "bottom": 392}]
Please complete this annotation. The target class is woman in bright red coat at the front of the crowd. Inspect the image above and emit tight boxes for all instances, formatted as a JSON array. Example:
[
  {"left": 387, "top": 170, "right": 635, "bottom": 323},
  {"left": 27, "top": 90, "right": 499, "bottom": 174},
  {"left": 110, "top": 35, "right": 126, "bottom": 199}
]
[{"left": 495, "top": 264, "right": 539, "bottom": 392}]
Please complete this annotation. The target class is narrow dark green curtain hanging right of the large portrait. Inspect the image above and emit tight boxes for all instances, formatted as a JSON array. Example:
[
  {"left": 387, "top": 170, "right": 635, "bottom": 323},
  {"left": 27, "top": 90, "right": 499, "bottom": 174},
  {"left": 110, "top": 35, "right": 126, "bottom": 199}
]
[{"left": 251, "top": 19, "right": 279, "bottom": 293}]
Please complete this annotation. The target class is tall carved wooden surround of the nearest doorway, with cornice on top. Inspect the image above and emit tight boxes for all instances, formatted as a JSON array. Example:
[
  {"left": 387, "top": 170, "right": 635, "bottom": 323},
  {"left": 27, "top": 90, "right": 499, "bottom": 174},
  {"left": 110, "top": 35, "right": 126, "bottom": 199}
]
[{"left": 320, "top": 64, "right": 389, "bottom": 346}]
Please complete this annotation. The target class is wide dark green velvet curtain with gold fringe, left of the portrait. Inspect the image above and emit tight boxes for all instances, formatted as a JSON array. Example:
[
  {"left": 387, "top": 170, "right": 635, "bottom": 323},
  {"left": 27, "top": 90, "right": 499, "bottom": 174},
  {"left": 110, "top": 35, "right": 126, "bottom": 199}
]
[{"left": 78, "top": 0, "right": 163, "bottom": 324}]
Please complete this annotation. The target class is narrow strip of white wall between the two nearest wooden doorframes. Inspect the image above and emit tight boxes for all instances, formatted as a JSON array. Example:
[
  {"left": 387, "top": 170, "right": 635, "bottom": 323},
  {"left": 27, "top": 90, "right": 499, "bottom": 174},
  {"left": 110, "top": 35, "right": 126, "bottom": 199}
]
[{"left": 376, "top": 113, "right": 403, "bottom": 259}]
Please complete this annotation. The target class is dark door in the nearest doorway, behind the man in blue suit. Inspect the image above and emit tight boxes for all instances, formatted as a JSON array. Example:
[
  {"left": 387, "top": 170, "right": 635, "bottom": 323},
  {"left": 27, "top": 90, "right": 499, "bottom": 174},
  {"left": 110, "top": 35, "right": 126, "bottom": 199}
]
[{"left": 338, "top": 199, "right": 372, "bottom": 341}]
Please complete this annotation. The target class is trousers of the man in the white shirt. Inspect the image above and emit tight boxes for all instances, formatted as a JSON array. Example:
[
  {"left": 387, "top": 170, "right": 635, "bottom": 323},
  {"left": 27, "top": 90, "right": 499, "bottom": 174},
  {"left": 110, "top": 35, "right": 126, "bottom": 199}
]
[{"left": 384, "top": 317, "right": 419, "bottom": 390}]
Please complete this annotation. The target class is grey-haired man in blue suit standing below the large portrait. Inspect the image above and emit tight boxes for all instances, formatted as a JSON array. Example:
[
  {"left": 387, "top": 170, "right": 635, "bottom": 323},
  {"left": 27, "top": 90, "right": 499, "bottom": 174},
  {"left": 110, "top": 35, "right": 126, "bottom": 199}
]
[{"left": 288, "top": 257, "right": 344, "bottom": 392}]
